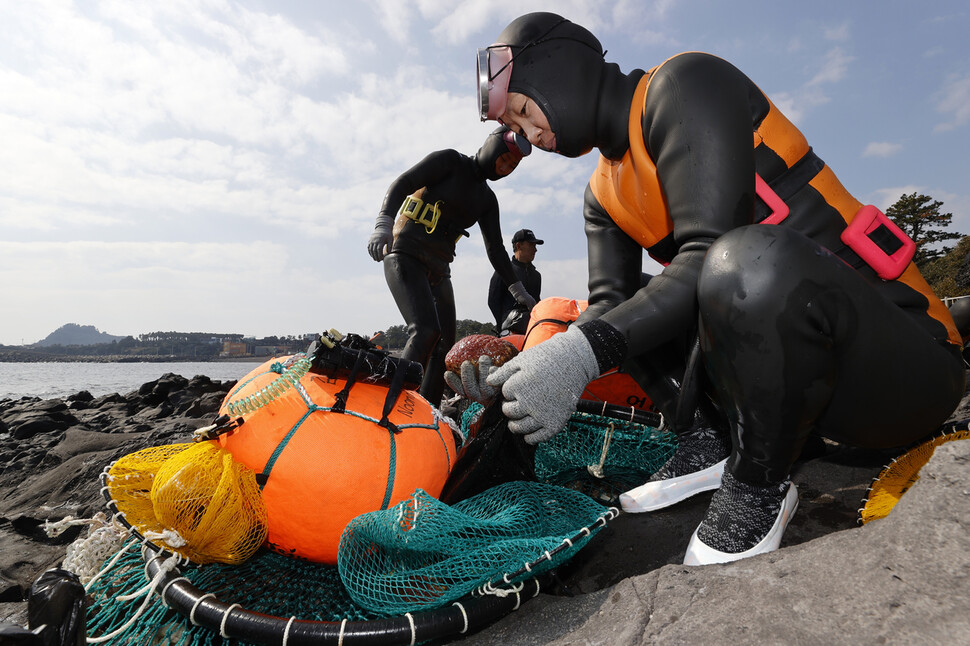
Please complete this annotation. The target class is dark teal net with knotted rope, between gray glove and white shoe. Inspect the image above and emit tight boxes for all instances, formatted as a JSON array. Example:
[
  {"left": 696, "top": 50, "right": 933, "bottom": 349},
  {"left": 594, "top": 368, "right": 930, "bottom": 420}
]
[{"left": 535, "top": 402, "right": 677, "bottom": 504}]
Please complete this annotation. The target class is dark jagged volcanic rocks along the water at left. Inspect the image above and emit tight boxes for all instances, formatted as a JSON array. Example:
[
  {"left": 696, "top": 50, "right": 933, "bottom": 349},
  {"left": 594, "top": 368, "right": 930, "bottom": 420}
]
[{"left": 0, "top": 374, "right": 235, "bottom": 621}]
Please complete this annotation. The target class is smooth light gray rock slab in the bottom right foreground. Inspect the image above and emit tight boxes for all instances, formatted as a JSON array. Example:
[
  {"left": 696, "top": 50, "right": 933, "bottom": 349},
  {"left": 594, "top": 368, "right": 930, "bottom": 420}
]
[{"left": 461, "top": 441, "right": 970, "bottom": 646}]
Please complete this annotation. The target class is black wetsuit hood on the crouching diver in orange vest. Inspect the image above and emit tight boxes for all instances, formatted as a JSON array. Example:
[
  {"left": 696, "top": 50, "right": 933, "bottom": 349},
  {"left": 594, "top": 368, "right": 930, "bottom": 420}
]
[{"left": 496, "top": 12, "right": 643, "bottom": 158}]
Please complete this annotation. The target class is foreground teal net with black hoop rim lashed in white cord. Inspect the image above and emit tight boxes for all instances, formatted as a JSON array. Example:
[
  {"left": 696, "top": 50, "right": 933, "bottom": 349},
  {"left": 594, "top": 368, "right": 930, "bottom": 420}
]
[{"left": 87, "top": 482, "right": 619, "bottom": 646}]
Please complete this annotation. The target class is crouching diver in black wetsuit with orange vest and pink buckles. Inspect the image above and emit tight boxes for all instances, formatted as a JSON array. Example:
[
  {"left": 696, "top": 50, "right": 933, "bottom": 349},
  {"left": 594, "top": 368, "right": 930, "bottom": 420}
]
[{"left": 478, "top": 13, "right": 966, "bottom": 564}]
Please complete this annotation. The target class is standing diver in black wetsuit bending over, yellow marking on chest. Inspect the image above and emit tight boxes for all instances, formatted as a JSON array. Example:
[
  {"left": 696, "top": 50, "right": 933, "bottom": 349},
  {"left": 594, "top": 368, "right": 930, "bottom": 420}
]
[{"left": 367, "top": 126, "right": 535, "bottom": 407}]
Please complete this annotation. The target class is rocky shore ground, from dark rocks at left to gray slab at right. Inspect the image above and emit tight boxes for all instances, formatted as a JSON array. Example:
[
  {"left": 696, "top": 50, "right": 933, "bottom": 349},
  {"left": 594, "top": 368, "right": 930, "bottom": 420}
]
[{"left": 0, "top": 374, "right": 970, "bottom": 646}]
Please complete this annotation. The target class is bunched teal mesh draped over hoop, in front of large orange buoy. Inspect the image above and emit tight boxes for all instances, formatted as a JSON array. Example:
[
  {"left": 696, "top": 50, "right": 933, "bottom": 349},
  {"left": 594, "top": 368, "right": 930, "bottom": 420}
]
[{"left": 337, "top": 482, "right": 616, "bottom": 614}]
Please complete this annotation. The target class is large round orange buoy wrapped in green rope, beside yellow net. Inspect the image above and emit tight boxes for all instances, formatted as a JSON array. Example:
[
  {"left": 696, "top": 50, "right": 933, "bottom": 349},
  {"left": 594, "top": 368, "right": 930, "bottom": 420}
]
[{"left": 219, "top": 355, "right": 455, "bottom": 564}]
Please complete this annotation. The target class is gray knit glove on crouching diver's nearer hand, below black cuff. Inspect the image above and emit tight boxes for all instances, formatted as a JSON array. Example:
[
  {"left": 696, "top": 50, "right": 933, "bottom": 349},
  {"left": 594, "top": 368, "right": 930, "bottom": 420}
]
[{"left": 487, "top": 327, "right": 600, "bottom": 444}]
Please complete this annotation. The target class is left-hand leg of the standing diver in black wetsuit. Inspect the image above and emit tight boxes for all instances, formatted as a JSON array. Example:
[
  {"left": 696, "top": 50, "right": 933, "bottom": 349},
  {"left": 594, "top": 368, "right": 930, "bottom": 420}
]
[{"left": 384, "top": 253, "right": 441, "bottom": 384}]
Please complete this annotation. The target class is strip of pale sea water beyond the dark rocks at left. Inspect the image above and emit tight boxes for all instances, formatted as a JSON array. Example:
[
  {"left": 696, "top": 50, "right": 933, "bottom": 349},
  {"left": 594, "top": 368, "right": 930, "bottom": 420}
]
[{"left": 0, "top": 361, "right": 258, "bottom": 399}]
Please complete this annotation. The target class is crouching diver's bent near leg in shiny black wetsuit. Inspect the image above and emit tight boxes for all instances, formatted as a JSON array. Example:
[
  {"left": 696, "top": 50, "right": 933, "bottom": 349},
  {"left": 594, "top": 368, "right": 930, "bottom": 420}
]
[{"left": 698, "top": 225, "right": 965, "bottom": 484}]
